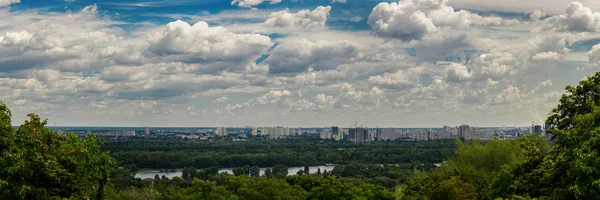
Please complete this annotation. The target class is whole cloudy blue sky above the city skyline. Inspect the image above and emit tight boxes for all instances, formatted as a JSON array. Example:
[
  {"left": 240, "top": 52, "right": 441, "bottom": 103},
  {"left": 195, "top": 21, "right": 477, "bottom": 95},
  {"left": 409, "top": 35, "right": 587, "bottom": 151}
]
[{"left": 0, "top": 0, "right": 600, "bottom": 127}]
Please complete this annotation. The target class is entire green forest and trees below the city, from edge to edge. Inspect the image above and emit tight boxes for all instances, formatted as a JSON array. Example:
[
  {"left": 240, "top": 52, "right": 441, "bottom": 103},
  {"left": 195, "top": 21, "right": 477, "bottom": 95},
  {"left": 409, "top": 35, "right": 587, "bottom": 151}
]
[{"left": 0, "top": 73, "right": 600, "bottom": 200}]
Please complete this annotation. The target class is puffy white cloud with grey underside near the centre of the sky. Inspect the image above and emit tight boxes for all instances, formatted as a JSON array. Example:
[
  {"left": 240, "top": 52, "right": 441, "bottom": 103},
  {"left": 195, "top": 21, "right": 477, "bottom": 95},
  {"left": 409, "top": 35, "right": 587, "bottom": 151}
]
[{"left": 264, "top": 39, "right": 360, "bottom": 74}]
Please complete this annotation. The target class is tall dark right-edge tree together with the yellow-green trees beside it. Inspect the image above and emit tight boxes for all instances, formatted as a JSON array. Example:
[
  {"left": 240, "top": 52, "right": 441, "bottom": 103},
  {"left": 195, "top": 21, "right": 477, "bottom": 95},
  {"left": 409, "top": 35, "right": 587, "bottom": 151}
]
[{"left": 396, "top": 72, "right": 600, "bottom": 199}]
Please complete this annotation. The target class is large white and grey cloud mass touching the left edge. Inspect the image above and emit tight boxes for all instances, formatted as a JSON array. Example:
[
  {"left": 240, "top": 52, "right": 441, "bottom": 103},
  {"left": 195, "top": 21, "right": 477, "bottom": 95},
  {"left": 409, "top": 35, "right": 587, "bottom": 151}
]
[{"left": 0, "top": 9, "right": 117, "bottom": 73}]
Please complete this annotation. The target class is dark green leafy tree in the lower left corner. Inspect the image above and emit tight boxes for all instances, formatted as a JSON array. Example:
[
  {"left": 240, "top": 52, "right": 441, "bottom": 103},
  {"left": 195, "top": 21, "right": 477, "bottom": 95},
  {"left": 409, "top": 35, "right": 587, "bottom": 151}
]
[{"left": 0, "top": 104, "right": 115, "bottom": 199}]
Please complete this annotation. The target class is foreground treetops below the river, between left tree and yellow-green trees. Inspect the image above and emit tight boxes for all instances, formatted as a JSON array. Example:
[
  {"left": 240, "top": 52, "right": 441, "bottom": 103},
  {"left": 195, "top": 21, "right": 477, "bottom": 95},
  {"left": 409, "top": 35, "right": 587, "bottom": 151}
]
[{"left": 108, "top": 168, "right": 395, "bottom": 200}]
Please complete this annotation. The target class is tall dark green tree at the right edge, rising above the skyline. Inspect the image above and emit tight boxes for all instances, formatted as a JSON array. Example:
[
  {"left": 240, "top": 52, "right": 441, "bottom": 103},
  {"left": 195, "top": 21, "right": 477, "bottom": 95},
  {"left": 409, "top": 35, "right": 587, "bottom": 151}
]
[{"left": 511, "top": 72, "right": 600, "bottom": 199}]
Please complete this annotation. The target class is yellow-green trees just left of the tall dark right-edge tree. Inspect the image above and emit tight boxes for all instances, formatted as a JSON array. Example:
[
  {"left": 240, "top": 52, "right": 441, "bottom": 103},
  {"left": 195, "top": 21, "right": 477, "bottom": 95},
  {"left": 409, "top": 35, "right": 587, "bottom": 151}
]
[{"left": 403, "top": 135, "right": 548, "bottom": 199}]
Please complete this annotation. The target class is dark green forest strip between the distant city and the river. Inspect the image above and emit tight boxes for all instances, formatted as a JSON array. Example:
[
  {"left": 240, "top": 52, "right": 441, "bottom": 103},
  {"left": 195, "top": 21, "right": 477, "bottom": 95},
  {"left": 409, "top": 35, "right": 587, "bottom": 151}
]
[{"left": 104, "top": 138, "right": 454, "bottom": 169}]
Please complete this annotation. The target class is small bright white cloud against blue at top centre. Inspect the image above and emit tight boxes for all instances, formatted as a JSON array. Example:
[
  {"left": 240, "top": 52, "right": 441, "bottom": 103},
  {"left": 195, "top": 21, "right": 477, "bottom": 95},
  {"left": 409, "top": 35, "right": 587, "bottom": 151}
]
[{"left": 265, "top": 6, "right": 331, "bottom": 28}]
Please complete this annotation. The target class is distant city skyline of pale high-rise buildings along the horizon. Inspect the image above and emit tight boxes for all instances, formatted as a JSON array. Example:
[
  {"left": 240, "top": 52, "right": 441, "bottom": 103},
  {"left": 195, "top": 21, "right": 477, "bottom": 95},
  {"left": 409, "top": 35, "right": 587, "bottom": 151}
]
[{"left": 50, "top": 122, "right": 550, "bottom": 142}]
